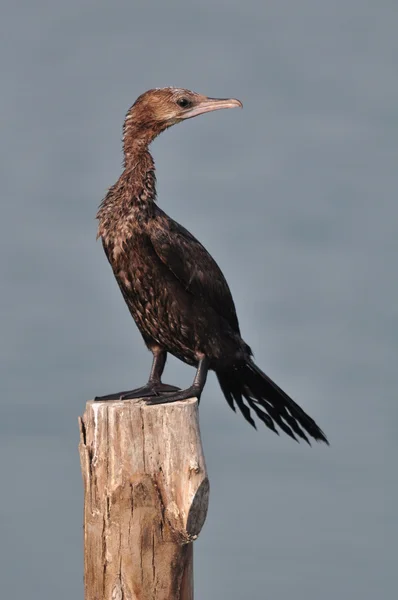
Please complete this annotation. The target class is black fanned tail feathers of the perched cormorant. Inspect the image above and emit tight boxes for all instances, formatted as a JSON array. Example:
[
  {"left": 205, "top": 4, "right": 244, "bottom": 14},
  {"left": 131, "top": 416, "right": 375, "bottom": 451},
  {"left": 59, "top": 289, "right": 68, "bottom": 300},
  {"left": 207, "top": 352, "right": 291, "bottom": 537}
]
[{"left": 216, "top": 361, "right": 329, "bottom": 445}]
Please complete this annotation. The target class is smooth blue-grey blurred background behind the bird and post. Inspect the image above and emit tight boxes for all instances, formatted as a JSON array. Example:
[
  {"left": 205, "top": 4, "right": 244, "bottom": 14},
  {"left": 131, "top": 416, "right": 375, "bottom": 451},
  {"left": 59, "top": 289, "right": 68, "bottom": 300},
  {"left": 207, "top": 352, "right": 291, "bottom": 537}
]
[{"left": 0, "top": 0, "right": 398, "bottom": 600}]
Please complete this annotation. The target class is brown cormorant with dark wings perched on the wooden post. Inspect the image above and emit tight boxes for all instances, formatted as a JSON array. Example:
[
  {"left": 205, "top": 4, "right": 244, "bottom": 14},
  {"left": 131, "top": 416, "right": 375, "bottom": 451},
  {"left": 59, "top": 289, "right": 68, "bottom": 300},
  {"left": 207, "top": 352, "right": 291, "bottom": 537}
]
[{"left": 95, "top": 87, "right": 328, "bottom": 444}]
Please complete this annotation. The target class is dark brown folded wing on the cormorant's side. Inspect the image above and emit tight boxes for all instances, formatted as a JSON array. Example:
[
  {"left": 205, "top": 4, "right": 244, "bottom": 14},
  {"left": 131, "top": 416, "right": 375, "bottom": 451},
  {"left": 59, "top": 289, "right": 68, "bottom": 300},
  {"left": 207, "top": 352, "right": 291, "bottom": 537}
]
[{"left": 149, "top": 211, "right": 239, "bottom": 333}]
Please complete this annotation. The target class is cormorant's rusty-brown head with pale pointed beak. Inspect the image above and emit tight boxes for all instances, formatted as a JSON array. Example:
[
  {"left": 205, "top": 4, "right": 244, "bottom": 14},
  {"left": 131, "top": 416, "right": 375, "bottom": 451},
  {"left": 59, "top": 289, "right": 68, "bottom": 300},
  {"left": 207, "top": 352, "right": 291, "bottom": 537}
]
[{"left": 123, "top": 87, "right": 242, "bottom": 157}]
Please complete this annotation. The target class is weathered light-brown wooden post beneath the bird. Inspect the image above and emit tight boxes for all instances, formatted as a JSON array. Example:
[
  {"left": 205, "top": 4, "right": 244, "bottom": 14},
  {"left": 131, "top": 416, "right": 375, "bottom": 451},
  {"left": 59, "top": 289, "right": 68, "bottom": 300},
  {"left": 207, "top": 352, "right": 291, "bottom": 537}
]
[{"left": 79, "top": 398, "right": 209, "bottom": 600}]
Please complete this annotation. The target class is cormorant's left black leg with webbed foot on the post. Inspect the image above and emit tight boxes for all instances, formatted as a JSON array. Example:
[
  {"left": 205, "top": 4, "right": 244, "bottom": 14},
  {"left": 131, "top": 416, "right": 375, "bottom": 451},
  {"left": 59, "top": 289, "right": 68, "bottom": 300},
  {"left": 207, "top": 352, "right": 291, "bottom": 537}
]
[{"left": 95, "top": 347, "right": 180, "bottom": 402}]
